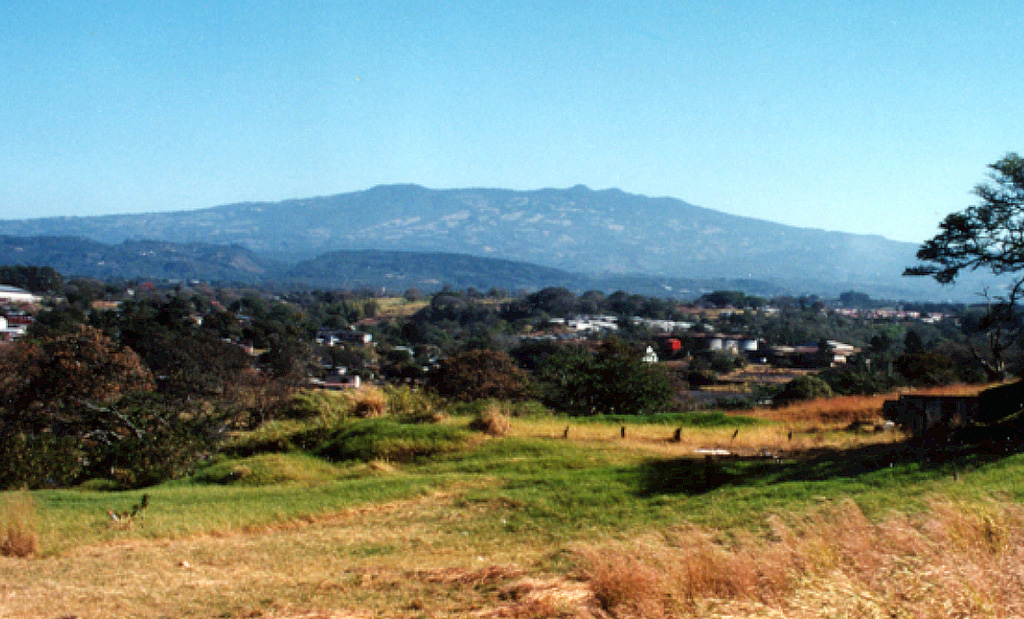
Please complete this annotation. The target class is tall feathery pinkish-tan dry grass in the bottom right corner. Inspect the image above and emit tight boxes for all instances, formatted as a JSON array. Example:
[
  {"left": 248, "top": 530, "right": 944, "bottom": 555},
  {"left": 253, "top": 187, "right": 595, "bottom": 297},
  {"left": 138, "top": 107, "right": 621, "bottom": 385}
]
[{"left": 580, "top": 500, "right": 1024, "bottom": 619}]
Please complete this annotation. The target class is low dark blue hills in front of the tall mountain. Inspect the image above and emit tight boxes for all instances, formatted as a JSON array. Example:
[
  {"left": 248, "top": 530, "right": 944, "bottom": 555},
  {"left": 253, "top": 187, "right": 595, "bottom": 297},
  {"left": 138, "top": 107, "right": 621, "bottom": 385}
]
[{"left": 0, "top": 236, "right": 802, "bottom": 298}]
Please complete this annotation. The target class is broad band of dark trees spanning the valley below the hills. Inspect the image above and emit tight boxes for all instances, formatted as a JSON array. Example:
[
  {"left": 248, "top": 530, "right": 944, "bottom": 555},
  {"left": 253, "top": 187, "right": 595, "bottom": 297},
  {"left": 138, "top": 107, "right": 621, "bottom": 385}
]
[{"left": 0, "top": 267, "right": 1024, "bottom": 487}]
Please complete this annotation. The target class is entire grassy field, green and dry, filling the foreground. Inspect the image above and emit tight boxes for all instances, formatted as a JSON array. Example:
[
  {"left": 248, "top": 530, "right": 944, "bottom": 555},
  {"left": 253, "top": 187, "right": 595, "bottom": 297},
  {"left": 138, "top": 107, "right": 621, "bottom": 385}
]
[{"left": 0, "top": 385, "right": 1024, "bottom": 618}]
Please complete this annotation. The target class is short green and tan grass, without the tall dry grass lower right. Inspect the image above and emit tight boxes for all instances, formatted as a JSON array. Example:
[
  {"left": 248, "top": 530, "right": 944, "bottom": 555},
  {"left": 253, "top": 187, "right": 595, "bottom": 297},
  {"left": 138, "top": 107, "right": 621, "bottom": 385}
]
[{"left": 8, "top": 403, "right": 1024, "bottom": 619}]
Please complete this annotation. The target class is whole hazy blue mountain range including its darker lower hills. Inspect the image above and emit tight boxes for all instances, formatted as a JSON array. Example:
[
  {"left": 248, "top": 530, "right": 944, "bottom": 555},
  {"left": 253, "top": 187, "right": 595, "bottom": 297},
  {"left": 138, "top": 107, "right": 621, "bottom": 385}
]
[{"left": 0, "top": 184, "right": 975, "bottom": 300}]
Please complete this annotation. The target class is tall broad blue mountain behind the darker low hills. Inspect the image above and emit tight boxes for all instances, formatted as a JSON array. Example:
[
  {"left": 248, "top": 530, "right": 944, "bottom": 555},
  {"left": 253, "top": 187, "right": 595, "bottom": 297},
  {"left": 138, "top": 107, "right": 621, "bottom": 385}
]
[{"left": 0, "top": 184, "right": 973, "bottom": 298}]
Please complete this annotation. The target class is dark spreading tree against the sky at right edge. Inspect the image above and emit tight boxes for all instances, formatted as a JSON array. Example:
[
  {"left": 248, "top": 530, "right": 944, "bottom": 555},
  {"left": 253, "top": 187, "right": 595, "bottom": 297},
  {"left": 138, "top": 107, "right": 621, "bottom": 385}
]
[{"left": 903, "top": 153, "right": 1024, "bottom": 379}]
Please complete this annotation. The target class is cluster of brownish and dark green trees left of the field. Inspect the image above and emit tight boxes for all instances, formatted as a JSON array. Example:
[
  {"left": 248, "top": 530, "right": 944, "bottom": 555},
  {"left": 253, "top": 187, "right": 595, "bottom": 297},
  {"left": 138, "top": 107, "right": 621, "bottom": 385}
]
[{"left": 0, "top": 289, "right": 317, "bottom": 488}]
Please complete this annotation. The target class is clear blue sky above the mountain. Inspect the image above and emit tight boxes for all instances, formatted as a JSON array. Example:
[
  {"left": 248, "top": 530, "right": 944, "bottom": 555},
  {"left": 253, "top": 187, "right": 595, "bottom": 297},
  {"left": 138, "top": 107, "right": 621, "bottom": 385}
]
[{"left": 0, "top": 0, "right": 1024, "bottom": 242}]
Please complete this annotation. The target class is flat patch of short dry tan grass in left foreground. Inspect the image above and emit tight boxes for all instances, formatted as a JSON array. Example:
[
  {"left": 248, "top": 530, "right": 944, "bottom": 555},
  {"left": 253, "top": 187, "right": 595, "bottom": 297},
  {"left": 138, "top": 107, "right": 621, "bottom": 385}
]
[{"left": 0, "top": 487, "right": 573, "bottom": 619}]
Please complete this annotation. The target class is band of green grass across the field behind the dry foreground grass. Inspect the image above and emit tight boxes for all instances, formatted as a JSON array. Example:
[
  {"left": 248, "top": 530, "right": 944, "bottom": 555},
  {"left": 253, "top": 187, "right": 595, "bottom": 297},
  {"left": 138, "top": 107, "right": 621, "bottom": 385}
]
[{"left": 14, "top": 417, "right": 1024, "bottom": 552}]
